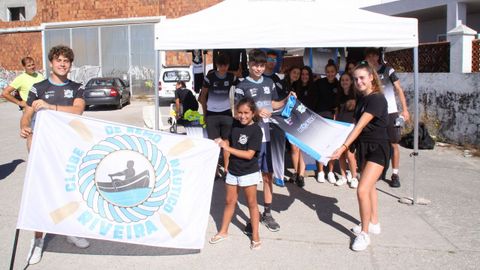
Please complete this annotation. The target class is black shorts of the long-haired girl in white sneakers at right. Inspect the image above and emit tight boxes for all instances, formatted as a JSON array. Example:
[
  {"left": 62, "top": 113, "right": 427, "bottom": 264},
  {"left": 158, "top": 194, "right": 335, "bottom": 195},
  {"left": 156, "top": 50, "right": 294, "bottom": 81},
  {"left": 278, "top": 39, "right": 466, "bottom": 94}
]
[{"left": 355, "top": 141, "right": 390, "bottom": 169}]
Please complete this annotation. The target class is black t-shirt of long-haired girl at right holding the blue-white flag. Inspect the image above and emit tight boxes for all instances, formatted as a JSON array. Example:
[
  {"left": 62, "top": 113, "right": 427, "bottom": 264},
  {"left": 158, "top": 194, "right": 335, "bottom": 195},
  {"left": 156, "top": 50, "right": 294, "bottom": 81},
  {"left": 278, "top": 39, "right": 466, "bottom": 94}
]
[{"left": 355, "top": 93, "right": 388, "bottom": 142}]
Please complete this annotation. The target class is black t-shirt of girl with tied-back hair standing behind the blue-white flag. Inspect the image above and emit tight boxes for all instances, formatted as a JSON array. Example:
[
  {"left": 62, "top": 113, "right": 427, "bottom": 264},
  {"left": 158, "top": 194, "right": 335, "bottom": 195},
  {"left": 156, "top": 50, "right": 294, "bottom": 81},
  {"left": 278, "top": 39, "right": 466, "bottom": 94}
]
[{"left": 315, "top": 78, "right": 338, "bottom": 113}]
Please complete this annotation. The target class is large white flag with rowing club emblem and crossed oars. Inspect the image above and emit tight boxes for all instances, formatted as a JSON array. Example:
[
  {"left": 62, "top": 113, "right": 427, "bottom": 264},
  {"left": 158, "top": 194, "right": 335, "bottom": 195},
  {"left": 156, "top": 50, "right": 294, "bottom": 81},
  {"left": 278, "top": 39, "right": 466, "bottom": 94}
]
[{"left": 17, "top": 111, "right": 220, "bottom": 249}]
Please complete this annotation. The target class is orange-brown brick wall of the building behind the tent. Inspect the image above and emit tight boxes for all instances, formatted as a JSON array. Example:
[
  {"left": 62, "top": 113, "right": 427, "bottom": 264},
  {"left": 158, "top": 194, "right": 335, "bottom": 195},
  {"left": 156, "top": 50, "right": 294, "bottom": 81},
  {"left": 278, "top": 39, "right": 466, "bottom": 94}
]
[{"left": 0, "top": 0, "right": 221, "bottom": 70}]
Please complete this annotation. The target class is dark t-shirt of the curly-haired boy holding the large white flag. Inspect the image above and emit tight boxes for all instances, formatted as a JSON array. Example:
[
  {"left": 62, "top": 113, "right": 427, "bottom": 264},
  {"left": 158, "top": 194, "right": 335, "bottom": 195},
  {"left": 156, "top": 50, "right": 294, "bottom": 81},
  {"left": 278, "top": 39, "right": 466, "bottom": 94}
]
[{"left": 27, "top": 79, "right": 84, "bottom": 106}]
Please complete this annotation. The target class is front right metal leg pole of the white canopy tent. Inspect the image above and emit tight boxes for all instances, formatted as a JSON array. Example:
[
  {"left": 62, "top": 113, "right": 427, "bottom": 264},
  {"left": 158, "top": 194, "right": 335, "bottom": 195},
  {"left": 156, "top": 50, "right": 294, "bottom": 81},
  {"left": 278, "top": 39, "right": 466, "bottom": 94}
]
[{"left": 412, "top": 46, "right": 419, "bottom": 205}]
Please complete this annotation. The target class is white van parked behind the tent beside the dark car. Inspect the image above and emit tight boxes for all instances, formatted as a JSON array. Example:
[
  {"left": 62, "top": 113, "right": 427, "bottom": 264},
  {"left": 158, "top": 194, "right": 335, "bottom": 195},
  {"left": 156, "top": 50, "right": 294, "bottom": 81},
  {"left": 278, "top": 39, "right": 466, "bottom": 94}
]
[{"left": 158, "top": 66, "right": 195, "bottom": 100}]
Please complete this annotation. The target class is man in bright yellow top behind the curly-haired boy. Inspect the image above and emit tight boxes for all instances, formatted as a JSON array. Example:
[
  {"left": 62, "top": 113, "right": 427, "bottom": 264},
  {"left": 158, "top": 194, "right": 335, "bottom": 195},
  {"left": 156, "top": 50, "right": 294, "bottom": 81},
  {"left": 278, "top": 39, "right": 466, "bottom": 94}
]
[{"left": 2, "top": 56, "right": 45, "bottom": 110}]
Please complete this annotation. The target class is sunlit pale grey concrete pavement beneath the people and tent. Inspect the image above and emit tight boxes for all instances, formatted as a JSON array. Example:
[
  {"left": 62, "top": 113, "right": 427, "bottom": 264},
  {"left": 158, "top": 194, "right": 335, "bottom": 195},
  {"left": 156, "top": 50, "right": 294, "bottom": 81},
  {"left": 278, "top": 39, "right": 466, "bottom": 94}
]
[{"left": 0, "top": 101, "right": 480, "bottom": 270}]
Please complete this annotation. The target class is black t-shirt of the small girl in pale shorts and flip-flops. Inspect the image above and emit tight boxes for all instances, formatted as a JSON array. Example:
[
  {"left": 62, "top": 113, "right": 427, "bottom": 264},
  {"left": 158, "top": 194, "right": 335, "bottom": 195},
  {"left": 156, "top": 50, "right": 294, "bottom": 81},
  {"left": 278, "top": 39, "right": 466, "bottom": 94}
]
[{"left": 228, "top": 120, "right": 262, "bottom": 176}]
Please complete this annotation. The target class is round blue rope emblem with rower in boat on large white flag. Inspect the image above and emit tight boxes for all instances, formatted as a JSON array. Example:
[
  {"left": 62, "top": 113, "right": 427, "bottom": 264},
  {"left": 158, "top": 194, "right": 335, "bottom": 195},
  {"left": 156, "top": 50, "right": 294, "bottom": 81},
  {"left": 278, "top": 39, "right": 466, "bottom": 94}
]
[{"left": 78, "top": 135, "right": 171, "bottom": 223}]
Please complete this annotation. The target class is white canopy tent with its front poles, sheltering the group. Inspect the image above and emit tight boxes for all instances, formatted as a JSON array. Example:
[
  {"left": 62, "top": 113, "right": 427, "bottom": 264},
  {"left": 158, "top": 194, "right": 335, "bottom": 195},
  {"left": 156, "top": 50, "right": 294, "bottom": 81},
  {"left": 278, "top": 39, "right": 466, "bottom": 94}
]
[{"left": 155, "top": 0, "right": 418, "bottom": 203}]
